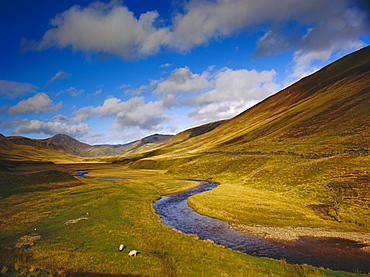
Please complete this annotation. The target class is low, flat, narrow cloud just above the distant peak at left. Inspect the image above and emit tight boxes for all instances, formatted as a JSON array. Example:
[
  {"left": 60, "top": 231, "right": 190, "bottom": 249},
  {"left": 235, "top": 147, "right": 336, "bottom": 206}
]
[{"left": 8, "top": 119, "right": 90, "bottom": 137}]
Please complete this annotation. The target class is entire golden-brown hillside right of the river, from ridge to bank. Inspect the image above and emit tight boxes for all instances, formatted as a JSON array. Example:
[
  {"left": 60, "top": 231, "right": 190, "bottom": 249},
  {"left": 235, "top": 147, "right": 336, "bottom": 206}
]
[{"left": 126, "top": 47, "right": 370, "bottom": 231}]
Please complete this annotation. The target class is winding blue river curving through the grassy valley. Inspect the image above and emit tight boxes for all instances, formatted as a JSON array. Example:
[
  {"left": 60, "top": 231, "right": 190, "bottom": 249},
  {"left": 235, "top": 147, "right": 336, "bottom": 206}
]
[{"left": 74, "top": 172, "right": 370, "bottom": 273}]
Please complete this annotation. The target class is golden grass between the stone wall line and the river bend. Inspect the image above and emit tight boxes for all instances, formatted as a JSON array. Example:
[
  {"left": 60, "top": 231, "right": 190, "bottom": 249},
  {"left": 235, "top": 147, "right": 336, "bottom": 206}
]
[{"left": 132, "top": 150, "right": 370, "bottom": 232}]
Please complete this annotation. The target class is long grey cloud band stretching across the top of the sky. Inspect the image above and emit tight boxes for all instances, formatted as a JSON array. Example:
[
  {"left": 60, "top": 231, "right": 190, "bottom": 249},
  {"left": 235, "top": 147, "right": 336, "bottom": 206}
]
[{"left": 26, "top": 0, "right": 370, "bottom": 62}]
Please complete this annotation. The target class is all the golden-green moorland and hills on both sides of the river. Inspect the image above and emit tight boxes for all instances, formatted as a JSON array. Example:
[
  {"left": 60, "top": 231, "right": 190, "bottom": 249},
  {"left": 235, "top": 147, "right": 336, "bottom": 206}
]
[{"left": 0, "top": 47, "right": 370, "bottom": 276}]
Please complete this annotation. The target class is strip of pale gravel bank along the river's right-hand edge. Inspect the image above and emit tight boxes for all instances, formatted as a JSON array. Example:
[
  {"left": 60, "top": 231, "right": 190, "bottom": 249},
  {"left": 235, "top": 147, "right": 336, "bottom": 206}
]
[{"left": 231, "top": 223, "right": 370, "bottom": 253}]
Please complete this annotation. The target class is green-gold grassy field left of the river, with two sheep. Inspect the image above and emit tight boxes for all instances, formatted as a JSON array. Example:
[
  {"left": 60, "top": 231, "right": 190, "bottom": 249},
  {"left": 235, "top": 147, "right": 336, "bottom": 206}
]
[{"left": 0, "top": 164, "right": 366, "bottom": 276}]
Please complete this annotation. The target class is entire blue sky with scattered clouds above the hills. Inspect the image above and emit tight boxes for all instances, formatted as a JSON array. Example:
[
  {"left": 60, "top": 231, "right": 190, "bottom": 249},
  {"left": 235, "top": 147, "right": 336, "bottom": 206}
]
[{"left": 0, "top": 0, "right": 370, "bottom": 144}]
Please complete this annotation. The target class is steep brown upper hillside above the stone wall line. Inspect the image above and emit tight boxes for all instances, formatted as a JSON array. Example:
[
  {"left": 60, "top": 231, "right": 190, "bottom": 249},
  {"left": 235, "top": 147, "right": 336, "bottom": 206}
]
[{"left": 132, "top": 47, "right": 370, "bottom": 157}]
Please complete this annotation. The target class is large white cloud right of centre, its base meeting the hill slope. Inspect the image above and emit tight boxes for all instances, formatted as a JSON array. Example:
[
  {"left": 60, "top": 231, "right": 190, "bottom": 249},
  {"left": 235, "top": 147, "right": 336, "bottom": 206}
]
[{"left": 184, "top": 68, "right": 280, "bottom": 123}]
